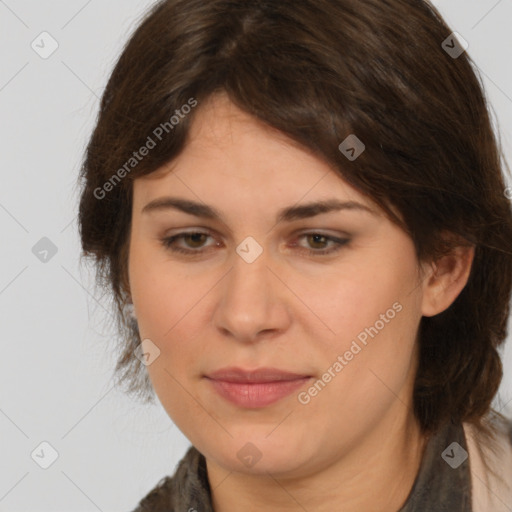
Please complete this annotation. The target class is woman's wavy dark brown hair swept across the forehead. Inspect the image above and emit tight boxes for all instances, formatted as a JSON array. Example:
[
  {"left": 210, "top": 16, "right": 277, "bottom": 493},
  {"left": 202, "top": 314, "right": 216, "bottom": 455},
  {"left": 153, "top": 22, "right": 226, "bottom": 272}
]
[{"left": 79, "top": 0, "right": 512, "bottom": 444}]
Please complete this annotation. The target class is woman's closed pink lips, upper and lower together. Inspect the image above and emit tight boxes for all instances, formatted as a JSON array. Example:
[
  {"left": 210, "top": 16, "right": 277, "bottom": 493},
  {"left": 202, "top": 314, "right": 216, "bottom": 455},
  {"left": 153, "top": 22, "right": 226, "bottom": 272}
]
[{"left": 205, "top": 368, "right": 312, "bottom": 409}]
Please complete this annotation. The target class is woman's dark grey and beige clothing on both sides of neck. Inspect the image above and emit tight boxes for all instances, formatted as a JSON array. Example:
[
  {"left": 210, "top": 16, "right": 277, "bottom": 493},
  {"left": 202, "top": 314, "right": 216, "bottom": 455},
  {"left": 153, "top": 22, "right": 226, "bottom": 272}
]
[{"left": 132, "top": 416, "right": 512, "bottom": 512}]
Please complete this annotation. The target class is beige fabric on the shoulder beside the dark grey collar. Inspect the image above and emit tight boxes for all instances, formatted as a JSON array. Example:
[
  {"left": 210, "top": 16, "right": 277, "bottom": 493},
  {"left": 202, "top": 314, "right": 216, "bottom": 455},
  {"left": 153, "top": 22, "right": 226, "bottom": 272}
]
[{"left": 463, "top": 415, "right": 512, "bottom": 512}]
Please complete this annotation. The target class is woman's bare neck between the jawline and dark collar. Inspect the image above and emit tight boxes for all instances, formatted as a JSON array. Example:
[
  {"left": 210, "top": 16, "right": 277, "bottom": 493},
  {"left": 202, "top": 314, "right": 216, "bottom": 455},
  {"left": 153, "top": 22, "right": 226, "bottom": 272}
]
[{"left": 206, "top": 408, "right": 427, "bottom": 512}]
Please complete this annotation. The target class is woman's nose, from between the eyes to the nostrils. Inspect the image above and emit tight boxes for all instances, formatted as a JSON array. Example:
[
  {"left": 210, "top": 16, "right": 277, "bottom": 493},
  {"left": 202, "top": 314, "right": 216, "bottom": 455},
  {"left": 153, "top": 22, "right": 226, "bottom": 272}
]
[{"left": 214, "top": 244, "right": 293, "bottom": 343}]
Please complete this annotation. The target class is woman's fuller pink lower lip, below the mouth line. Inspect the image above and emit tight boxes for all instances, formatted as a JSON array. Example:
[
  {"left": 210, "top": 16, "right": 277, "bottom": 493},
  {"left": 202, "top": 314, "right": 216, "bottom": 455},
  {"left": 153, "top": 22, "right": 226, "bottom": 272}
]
[{"left": 208, "top": 377, "right": 311, "bottom": 408}]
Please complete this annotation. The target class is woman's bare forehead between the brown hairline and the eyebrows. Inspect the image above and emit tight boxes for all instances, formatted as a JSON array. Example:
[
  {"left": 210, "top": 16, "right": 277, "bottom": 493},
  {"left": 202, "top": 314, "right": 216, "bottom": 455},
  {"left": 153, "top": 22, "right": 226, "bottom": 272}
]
[{"left": 129, "top": 94, "right": 396, "bottom": 224}]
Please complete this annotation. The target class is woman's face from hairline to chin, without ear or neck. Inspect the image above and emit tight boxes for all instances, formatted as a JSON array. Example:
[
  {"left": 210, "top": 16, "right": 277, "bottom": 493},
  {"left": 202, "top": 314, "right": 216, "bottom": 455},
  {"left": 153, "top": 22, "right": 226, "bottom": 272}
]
[{"left": 129, "top": 91, "right": 432, "bottom": 475}]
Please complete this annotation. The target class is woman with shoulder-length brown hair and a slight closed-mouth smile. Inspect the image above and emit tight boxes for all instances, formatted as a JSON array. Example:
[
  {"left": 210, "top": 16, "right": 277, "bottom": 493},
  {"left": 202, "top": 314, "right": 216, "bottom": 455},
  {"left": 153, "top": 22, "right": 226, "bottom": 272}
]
[{"left": 79, "top": 0, "right": 512, "bottom": 512}]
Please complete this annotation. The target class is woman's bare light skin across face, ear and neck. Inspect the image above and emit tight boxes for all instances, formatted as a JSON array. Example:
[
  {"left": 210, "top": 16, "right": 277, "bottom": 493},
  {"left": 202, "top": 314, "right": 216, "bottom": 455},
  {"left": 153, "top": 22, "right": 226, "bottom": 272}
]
[{"left": 128, "top": 94, "right": 474, "bottom": 512}]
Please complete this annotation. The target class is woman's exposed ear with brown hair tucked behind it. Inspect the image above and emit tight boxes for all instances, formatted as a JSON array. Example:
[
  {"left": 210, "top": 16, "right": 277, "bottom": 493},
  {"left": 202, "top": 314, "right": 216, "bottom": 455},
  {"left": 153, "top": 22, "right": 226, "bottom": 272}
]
[{"left": 422, "top": 238, "right": 475, "bottom": 316}]
